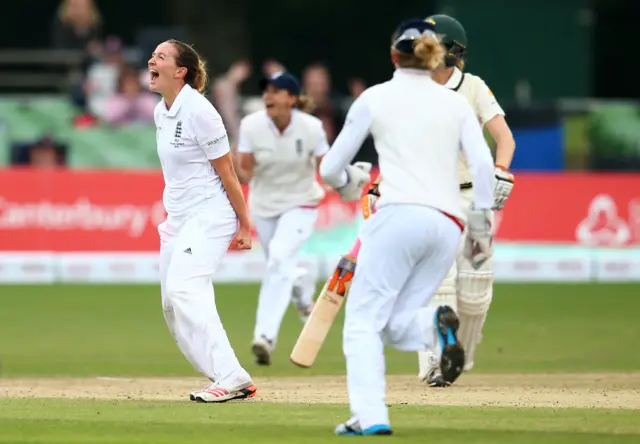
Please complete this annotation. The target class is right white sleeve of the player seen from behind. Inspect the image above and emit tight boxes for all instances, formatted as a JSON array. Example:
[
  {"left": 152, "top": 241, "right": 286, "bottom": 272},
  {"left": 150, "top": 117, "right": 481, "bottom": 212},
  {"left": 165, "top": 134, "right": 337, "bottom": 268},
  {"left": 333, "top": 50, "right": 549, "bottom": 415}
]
[{"left": 460, "top": 103, "right": 494, "bottom": 210}]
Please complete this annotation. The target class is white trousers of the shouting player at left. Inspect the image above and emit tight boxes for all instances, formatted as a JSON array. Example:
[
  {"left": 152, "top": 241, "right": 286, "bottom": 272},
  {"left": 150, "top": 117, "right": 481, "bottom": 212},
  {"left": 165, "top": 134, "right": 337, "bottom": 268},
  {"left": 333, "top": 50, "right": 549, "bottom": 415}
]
[{"left": 158, "top": 201, "right": 251, "bottom": 387}]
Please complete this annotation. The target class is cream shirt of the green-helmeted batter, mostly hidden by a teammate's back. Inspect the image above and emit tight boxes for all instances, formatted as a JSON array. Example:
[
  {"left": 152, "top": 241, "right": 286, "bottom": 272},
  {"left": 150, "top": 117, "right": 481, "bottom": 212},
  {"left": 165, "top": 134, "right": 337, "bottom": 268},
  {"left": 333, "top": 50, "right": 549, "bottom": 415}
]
[{"left": 444, "top": 68, "right": 504, "bottom": 183}]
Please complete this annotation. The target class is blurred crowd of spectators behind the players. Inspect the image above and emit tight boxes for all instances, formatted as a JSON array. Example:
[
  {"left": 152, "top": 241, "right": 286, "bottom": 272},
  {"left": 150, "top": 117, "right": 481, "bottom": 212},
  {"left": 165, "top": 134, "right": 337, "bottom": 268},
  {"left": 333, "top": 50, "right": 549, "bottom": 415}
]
[{"left": 45, "top": 0, "right": 366, "bottom": 149}]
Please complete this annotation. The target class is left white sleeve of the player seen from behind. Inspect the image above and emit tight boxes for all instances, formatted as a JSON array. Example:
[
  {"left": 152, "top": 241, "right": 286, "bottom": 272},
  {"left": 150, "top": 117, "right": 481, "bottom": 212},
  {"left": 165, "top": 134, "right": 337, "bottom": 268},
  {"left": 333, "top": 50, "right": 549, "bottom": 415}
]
[{"left": 320, "top": 93, "right": 372, "bottom": 188}]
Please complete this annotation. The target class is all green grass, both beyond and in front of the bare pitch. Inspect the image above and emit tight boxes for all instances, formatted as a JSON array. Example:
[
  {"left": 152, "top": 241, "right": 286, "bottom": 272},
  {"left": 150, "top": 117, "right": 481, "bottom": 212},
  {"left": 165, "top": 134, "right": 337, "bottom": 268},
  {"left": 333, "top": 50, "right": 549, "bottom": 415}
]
[{"left": 0, "top": 284, "right": 640, "bottom": 444}]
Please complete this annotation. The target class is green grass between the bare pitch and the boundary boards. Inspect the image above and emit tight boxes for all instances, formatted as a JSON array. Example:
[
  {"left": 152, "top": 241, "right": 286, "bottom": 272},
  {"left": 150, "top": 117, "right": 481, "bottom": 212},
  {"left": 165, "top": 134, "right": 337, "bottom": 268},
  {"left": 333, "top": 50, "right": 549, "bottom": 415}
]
[{"left": 0, "top": 284, "right": 640, "bottom": 376}]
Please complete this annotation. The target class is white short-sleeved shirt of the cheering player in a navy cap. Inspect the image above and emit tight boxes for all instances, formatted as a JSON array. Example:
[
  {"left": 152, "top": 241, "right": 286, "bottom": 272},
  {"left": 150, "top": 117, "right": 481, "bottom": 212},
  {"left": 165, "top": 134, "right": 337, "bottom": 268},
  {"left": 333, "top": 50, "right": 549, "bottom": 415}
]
[{"left": 238, "top": 110, "right": 329, "bottom": 217}]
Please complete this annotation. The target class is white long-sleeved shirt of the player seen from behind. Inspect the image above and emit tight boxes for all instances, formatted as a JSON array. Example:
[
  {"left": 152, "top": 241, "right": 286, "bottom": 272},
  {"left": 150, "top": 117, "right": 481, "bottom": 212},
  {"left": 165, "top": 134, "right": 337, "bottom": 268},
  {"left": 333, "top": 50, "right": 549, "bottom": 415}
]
[{"left": 320, "top": 69, "right": 494, "bottom": 221}]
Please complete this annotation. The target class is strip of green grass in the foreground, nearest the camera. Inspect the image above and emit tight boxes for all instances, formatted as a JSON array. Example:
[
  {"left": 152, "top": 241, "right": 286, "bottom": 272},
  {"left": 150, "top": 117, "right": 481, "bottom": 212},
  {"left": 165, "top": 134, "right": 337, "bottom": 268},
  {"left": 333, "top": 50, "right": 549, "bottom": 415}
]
[{"left": 0, "top": 400, "right": 640, "bottom": 444}]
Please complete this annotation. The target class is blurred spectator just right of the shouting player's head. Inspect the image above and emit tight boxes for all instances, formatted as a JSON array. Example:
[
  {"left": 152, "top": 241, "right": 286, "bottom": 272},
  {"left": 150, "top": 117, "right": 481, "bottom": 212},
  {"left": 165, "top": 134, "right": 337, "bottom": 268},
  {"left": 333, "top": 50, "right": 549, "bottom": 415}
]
[{"left": 211, "top": 60, "right": 252, "bottom": 142}]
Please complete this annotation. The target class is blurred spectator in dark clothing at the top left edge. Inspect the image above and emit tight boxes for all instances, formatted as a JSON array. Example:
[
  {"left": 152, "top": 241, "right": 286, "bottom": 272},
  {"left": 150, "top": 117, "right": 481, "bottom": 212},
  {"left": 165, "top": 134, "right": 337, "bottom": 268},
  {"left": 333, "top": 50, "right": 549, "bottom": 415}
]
[{"left": 51, "top": 0, "right": 102, "bottom": 57}]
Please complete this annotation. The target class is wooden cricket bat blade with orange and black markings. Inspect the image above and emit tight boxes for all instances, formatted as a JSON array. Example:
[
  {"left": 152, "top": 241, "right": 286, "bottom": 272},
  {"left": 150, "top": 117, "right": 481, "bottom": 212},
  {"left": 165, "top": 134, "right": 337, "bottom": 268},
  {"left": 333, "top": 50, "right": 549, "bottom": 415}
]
[{"left": 289, "top": 254, "right": 356, "bottom": 368}]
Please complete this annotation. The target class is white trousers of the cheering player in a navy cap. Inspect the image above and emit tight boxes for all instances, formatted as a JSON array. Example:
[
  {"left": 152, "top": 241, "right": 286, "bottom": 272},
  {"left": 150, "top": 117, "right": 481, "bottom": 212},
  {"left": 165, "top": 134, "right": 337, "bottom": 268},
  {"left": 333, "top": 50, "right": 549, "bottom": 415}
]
[{"left": 253, "top": 208, "right": 318, "bottom": 346}]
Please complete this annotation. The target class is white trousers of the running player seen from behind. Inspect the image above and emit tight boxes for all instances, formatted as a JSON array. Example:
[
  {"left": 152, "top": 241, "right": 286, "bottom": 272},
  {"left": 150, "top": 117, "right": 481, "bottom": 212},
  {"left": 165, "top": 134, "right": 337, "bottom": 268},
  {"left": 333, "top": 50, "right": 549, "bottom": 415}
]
[{"left": 343, "top": 204, "right": 462, "bottom": 428}]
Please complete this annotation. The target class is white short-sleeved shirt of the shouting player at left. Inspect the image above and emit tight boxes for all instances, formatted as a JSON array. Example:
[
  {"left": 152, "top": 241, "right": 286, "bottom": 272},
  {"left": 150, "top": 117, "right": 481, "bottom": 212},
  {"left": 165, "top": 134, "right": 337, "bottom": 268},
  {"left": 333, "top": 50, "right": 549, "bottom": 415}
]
[{"left": 154, "top": 85, "right": 231, "bottom": 216}]
